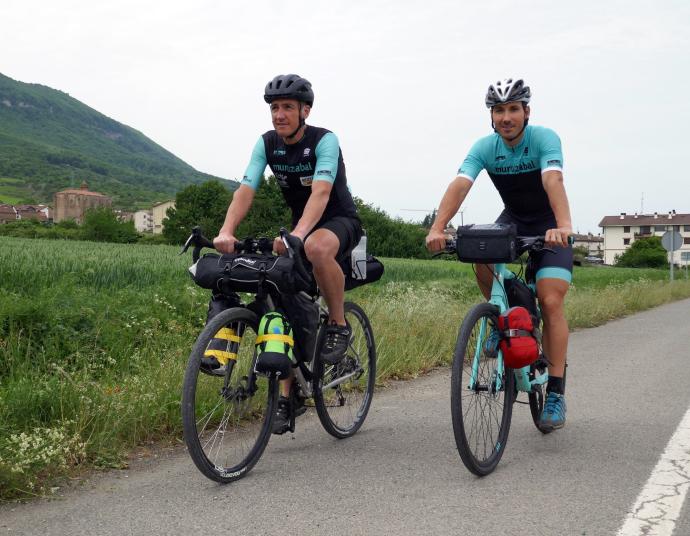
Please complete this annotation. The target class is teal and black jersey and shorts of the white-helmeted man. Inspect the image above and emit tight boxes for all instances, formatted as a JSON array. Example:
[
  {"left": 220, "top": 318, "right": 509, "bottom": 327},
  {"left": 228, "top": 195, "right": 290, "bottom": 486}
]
[{"left": 458, "top": 125, "right": 573, "bottom": 282}]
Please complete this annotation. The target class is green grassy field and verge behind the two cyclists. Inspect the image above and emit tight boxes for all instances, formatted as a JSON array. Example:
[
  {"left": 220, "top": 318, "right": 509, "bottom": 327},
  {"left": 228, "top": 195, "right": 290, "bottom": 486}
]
[{"left": 0, "top": 237, "right": 690, "bottom": 499}]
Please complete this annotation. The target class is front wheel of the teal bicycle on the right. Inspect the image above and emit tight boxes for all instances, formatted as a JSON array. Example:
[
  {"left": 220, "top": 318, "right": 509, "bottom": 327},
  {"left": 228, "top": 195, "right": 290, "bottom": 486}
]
[{"left": 450, "top": 303, "right": 516, "bottom": 476}]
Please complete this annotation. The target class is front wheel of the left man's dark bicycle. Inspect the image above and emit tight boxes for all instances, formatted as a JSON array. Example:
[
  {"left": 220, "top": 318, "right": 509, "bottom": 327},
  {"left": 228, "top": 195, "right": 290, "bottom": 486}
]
[{"left": 182, "top": 308, "right": 278, "bottom": 483}]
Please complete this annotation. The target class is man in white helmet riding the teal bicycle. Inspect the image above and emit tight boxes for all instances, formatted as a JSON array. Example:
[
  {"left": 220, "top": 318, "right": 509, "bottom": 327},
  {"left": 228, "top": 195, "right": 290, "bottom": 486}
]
[{"left": 426, "top": 79, "right": 573, "bottom": 429}]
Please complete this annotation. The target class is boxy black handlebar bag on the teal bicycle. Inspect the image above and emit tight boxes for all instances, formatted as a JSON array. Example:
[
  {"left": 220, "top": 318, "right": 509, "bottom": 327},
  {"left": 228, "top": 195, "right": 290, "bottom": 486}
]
[{"left": 456, "top": 223, "right": 518, "bottom": 264}]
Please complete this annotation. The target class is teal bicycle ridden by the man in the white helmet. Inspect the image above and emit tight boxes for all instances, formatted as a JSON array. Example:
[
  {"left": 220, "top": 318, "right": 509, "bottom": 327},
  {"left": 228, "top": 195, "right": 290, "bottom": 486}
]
[{"left": 445, "top": 228, "right": 572, "bottom": 476}]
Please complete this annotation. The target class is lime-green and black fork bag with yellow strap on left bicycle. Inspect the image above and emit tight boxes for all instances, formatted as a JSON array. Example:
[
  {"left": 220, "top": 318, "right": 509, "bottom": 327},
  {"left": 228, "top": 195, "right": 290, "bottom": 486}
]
[{"left": 254, "top": 312, "right": 296, "bottom": 378}]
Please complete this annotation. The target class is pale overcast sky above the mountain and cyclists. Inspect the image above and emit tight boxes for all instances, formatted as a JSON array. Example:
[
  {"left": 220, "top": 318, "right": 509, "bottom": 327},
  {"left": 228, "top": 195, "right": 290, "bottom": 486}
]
[{"left": 0, "top": 0, "right": 690, "bottom": 233}]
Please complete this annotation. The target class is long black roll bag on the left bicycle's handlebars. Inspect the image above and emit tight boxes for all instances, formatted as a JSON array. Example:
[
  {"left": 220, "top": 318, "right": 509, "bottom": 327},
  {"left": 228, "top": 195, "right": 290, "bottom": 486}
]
[{"left": 189, "top": 253, "right": 311, "bottom": 294}]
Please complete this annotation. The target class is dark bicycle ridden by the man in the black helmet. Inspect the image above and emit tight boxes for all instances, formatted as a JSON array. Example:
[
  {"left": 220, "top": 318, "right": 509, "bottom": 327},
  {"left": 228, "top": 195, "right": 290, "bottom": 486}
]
[{"left": 175, "top": 228, "right": 376, "bottom": 483}]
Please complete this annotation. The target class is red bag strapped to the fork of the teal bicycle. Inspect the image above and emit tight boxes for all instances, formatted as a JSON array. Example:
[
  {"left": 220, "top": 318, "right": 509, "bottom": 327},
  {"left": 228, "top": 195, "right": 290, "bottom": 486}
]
[{"left": 498, "top": 307, "right": 539, "bottom": 369}]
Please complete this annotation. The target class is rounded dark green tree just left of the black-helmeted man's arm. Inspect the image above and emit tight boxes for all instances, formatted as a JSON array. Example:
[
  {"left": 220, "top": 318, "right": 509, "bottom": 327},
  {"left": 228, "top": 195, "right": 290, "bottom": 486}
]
[{"left": 163, "top": 180, "right": 232, "bottom": 244}]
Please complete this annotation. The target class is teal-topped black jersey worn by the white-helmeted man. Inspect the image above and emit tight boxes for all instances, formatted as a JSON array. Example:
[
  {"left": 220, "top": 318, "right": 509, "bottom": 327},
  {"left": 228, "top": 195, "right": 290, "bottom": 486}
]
[{"left": 458, "top": 125, "right": 563, "bottom": 223}]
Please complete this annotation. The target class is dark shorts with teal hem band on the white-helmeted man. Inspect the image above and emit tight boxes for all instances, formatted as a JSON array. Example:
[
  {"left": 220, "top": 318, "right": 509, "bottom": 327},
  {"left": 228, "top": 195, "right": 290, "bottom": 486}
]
[{"left": 496, "top": 210, "right": 573, "bottom": 283}]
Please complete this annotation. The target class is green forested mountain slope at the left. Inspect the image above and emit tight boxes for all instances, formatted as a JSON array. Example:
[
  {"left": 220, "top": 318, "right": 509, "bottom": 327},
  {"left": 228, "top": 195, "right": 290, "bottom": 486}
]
[{"left": 0, "top": 74, "right": 238, "bottom": 208}]
